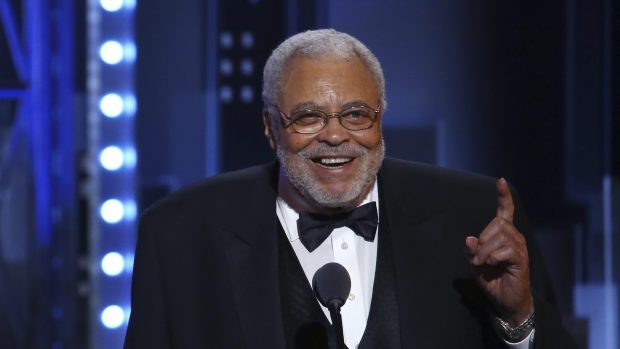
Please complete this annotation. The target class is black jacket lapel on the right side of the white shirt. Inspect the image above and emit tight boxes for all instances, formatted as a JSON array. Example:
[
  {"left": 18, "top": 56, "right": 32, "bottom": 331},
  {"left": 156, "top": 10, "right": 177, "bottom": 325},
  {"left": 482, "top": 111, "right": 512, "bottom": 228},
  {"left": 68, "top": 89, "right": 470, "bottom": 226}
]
[{"left": 379, "top": 164, "right": 445, "bottom": 349}]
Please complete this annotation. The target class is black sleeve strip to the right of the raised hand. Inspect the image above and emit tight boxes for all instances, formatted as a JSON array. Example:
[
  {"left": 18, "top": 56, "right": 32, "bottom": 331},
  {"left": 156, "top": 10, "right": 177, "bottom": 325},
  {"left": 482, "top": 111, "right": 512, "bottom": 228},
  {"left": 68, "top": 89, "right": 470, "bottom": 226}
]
[{"left": 511, "top": 187, "right": 576, "bottom": 349}]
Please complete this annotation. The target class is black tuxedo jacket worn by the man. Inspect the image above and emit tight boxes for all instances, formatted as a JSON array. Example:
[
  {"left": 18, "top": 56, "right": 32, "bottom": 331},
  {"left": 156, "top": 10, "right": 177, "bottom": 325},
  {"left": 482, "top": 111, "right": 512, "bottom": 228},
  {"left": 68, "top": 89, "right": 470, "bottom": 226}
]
[{"left": 125, "top": 159, "right": 572, "bottom": 349}]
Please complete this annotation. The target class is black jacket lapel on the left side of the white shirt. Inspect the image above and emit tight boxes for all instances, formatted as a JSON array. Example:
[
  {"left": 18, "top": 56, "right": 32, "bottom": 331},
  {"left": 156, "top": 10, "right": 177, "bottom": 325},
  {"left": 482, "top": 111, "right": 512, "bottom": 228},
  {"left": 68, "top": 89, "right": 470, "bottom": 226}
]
[{"left": 223, "top": 164, "right": 284, "bottom": 349}]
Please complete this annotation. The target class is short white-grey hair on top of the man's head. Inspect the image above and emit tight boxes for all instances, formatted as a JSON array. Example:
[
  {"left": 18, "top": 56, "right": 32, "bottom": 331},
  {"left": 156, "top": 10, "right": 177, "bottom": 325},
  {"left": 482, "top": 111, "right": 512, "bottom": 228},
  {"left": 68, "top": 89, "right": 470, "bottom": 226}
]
[{"left": 263, "top": 29, "right": 387, "bottom": 111}]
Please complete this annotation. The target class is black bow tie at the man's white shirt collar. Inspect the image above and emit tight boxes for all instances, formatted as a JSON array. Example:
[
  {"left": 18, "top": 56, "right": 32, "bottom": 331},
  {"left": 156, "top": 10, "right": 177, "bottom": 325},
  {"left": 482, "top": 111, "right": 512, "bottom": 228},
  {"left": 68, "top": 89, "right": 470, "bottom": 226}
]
[{"left": 297, "top": 201, "right": 379, "bottom": 252}]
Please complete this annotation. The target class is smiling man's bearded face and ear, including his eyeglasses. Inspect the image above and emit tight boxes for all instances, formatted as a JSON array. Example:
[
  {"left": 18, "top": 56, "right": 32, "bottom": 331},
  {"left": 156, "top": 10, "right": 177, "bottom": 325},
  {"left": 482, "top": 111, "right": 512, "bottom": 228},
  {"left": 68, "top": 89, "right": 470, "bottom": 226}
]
[{"left": 264, "top": 51, "right": 384, "bottom": 212}]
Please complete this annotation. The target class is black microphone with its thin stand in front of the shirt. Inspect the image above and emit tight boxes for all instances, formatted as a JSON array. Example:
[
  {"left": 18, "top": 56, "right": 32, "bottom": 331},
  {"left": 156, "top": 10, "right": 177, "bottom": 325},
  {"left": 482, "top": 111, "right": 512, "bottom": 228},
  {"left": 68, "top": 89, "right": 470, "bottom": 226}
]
[{"left": 312, "top": 263, "right": 351, "bottom": 349}]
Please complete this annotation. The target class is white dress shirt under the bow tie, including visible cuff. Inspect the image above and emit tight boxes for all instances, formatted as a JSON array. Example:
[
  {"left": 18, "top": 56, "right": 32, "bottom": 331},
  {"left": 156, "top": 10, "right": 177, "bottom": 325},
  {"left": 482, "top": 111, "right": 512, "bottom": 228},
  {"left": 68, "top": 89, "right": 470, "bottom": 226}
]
[{"left": 276, "top": 182, "right": 534, "bottom": 349}]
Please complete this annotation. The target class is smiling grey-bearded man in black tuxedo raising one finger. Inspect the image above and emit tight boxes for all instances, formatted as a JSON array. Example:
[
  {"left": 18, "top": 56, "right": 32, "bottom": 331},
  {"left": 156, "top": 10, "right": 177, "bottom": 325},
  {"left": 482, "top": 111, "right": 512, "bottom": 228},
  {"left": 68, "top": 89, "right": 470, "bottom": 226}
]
[{"left": 125, "top": 30, "right": 572, "bottom": 349}]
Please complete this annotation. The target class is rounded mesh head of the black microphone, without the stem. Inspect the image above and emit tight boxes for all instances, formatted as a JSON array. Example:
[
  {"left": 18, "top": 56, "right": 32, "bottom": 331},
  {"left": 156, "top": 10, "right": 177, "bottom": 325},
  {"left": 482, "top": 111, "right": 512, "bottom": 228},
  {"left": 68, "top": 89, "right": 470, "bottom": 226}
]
[{"left": 312, "top": 263, "right": 351, "bottom": 308}]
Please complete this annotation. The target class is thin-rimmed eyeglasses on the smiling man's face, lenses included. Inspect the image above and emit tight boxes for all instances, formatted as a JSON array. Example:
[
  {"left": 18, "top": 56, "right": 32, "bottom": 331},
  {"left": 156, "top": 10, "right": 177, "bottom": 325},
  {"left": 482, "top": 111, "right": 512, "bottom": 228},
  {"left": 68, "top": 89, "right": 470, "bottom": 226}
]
[{"left": 275, "top": 105, "right": 381, "bottom": 134}]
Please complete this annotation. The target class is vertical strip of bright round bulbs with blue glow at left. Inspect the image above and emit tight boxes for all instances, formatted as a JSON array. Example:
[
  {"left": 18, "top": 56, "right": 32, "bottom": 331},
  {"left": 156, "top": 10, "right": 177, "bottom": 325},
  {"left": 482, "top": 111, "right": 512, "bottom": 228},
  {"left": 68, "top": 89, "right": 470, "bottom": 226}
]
[{"left": 88, "top": 0, "right": 137, "bottom": 348}]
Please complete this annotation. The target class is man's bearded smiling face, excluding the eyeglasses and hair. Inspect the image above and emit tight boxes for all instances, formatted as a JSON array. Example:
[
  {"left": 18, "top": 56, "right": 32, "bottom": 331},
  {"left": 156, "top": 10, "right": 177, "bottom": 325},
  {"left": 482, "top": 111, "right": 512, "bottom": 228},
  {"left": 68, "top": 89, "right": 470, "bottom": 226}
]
[{"left": 266, "top": 56, "right": 384, "bottom": 209}]
